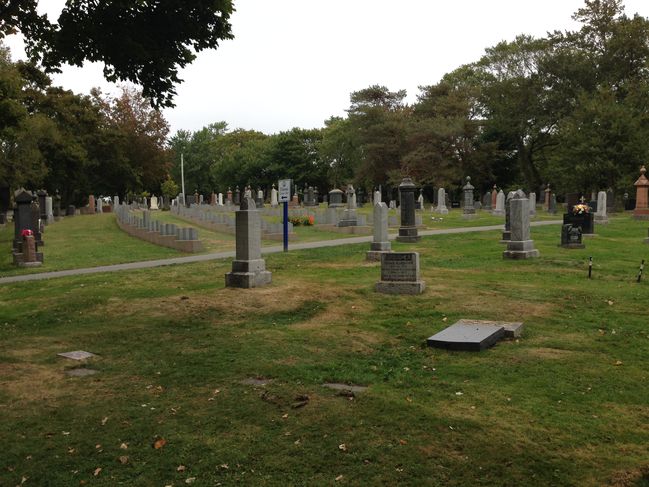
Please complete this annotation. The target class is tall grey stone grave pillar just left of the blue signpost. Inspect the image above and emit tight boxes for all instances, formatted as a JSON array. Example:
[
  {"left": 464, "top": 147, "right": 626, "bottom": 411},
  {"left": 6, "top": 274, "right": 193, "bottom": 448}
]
[{"left": 225, "top": 198, "right": 271, "bottom": 288}]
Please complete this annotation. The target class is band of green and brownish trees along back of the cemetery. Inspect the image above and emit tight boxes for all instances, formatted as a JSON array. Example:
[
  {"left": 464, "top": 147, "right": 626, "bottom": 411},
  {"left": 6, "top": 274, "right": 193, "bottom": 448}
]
[{"left": 0, "top": 0, "right": 649, "bottom": 206}]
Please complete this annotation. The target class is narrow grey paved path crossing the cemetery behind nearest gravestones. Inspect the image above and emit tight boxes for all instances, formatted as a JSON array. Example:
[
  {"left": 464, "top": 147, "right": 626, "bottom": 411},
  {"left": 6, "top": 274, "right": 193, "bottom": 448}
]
[{"left": 0, "top": 220, "right": 561, "bottom": 284}]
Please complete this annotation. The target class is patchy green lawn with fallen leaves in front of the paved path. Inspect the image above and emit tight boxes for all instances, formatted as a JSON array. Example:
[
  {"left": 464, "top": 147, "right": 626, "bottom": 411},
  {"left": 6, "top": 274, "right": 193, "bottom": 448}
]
[{"left": 0, "top": 217, "right": 649, "bottom": 487}]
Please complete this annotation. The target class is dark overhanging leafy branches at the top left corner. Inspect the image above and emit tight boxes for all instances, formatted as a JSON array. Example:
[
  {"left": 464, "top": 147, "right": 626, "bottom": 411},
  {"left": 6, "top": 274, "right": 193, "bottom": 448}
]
[{"left": 0, "top": 0, "right": 234, "bottom": 107}]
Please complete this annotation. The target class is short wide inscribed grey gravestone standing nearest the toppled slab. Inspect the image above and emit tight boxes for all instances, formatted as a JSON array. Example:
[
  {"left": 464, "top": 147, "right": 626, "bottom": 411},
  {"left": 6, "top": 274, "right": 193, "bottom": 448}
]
[{"left": 376, "top": 252, "right": 426, "bottom": 294}]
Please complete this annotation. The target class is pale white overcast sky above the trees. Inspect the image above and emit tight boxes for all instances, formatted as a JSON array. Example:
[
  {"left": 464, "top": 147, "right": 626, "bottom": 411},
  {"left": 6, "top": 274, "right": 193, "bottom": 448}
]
[{"left": 7, "top": 0, "right": 649, "bottom": 134}]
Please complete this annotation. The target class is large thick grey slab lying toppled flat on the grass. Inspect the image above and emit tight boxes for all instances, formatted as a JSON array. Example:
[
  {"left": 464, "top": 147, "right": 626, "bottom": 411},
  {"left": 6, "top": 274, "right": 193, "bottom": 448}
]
[{"left": 427, "top": 323, "right": 505, "bottom": 352}]
